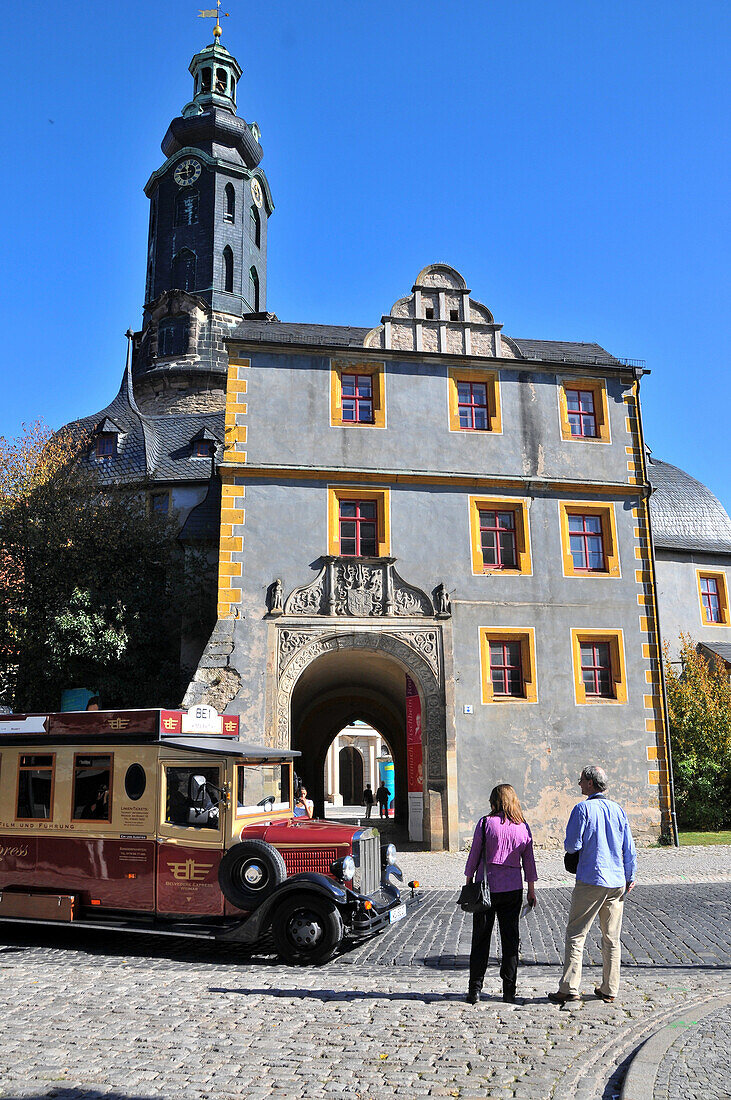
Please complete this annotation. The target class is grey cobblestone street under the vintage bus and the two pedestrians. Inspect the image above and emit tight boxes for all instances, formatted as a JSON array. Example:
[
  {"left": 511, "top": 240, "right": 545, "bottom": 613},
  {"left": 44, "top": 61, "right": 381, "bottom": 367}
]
[{"left": 0, "top": 857, "right": 731, "bottom": 1100}]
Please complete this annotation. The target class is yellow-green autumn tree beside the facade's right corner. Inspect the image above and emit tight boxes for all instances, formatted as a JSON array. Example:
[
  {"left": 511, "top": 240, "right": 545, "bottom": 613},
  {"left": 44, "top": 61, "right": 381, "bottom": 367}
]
[{"left": 663, "top": 634, "right": 731, "bottom": 829}]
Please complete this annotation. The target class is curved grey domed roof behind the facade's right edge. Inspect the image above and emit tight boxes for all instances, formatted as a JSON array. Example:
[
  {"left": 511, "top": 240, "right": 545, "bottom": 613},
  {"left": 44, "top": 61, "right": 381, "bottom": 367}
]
[{"left": 647, "top": 455, "right": 731, "bottom": 553}]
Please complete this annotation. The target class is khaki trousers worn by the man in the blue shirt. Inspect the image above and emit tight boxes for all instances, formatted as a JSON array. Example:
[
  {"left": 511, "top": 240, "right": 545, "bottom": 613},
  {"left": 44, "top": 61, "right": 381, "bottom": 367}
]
[{"left": 558, "top": 881, "right": 624, "bottom": 997}]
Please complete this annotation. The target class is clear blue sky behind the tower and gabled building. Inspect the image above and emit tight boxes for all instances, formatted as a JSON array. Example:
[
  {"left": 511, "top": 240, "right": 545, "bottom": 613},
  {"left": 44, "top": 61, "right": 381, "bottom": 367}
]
[{"left": 0, "top": 0, "right": 731, "bottom": 510}]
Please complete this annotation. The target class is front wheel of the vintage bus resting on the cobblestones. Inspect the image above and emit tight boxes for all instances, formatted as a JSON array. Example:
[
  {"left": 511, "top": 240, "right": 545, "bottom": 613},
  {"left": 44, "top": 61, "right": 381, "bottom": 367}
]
[{"left": 272, "top": 894, "right": 343, "bottom": 966}]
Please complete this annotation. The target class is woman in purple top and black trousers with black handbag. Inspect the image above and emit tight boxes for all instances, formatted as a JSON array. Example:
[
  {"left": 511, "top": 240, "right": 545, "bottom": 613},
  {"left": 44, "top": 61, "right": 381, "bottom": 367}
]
[{"left": 465, "top": 783, "right": 538, "bottom": 1004}]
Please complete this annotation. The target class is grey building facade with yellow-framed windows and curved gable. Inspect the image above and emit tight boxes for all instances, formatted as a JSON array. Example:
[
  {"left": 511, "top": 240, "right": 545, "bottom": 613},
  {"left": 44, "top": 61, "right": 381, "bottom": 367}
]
[{"left": 187, "top": 264, "right": 669, "bottom": 848}]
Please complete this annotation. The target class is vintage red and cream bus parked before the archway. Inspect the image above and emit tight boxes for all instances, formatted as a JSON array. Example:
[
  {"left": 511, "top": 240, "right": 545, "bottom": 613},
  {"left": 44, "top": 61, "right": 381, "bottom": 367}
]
[{"left": 0, "top": 706, "right": 419, "bottom": 964}]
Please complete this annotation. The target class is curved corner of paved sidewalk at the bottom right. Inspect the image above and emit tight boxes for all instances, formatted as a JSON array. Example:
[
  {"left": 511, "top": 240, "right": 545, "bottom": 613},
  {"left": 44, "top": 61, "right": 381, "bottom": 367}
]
[{"left": 653, "top": 1005, "right": 731, "bottom": 1100}]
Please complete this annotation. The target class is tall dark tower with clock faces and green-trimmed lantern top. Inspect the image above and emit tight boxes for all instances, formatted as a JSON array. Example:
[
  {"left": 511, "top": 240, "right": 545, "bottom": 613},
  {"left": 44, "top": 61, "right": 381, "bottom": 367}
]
[{"left": 133, "top": 25, "right": 274, "bottom": 414}]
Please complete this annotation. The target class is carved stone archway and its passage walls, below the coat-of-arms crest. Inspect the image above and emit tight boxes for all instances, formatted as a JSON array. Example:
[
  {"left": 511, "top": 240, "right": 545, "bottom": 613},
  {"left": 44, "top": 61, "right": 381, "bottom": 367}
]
[{"left": 273, "top": 620, "right": 458, "bottom": 850}]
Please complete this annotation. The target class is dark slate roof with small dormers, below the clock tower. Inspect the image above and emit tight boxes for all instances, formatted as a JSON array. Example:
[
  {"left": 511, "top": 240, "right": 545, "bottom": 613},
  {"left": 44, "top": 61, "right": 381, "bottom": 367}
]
[{"left": 68, "top": 365, "right": 224, "bottom": 484}]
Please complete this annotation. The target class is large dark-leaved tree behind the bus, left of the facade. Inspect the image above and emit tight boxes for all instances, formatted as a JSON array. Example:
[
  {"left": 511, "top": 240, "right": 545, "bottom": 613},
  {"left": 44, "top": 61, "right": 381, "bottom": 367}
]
[{"left": 0, "top": 425, "right": 212, "bottom": 711}]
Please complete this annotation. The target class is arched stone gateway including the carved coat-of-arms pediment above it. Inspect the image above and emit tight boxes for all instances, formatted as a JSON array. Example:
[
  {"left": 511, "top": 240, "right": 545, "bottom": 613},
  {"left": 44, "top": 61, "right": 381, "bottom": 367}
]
[{"left": 270, "top": 558, "right": 458, "bottom": 849}]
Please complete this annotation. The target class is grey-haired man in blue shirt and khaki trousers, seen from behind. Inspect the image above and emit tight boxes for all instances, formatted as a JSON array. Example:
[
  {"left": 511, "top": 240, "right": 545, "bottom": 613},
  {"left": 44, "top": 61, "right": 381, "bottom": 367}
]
[{"left": 549, "top": 765, "right": 638, "bottom": 1004}]
